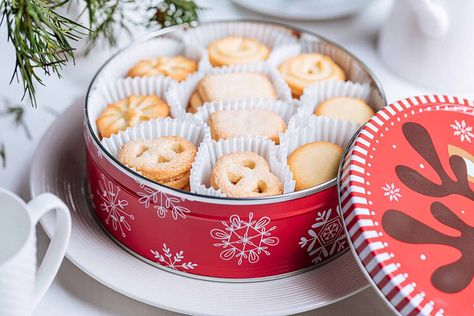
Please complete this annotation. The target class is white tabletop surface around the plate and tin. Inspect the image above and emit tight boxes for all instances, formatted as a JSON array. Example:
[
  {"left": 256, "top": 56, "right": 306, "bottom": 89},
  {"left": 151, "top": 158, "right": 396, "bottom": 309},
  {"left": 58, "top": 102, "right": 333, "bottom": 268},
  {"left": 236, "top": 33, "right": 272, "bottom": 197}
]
[{"left": 0, "top": 0, "right": 472, "bottom": 316}]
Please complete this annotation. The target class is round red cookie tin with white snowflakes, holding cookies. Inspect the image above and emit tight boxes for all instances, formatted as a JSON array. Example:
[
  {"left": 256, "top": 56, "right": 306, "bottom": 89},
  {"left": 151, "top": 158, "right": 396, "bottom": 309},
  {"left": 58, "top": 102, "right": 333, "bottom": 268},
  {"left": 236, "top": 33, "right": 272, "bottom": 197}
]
[{"left": 84, "top": 21, "right": 384, "bottom": 281}]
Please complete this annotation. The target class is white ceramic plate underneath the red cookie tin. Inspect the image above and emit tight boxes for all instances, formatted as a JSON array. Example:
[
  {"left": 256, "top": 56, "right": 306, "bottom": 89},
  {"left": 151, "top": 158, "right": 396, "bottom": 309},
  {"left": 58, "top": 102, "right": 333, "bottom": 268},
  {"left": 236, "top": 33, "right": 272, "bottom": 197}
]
[{"left": 30, "top": 102, "right": 368, "bottom": 315}]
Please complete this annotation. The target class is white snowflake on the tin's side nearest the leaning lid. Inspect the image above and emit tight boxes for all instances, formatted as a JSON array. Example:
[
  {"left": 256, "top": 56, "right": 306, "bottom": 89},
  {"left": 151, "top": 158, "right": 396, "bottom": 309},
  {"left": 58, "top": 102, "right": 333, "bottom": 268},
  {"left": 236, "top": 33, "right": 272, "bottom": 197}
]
[{"left": 299, "top": 209, "right": 346, "bottom": 264}]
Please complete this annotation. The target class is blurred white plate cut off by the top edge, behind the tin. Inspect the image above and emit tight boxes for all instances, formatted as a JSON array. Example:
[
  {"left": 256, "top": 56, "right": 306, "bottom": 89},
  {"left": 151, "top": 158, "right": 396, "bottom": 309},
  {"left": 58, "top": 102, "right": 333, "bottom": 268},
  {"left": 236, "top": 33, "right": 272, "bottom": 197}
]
[{"left": 232, "top": 0, "right": 372, "bottom": 21}]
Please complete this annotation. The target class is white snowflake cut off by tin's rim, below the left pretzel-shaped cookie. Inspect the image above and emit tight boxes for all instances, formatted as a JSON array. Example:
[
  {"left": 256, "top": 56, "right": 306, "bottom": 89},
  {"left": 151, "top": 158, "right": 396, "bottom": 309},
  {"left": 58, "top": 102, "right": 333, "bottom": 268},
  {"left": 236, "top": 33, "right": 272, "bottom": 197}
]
[{"left": 136, "top": 181, "right": 191, "bottom": 220}]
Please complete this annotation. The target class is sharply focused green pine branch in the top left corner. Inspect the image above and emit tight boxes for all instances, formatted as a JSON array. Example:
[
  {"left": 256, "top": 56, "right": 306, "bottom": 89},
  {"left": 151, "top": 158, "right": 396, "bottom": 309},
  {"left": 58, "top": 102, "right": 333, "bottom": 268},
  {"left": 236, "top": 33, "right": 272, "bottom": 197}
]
[{"left": 0, "top": 0, "right": 85, "bottom": 106}]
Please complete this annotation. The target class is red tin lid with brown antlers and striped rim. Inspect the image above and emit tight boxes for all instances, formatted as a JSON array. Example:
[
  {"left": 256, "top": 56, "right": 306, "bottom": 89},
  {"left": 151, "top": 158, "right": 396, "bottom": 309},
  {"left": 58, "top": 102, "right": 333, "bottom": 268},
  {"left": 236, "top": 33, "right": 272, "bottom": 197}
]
[{"left": 338, "top": 96, "right": 474, "bottom": 316}]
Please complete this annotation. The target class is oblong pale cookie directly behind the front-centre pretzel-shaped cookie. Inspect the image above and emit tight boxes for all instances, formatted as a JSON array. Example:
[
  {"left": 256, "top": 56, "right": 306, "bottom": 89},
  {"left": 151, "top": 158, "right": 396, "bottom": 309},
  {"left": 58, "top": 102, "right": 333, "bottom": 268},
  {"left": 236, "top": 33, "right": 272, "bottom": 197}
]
[{"left": 208, "top": 109, "right": 286, "bottom": 144}]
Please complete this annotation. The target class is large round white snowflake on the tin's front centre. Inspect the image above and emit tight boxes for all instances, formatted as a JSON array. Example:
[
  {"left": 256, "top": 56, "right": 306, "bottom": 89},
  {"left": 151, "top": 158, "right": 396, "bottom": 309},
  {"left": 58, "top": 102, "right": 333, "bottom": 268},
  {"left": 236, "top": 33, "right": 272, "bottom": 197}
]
[{"left": 211, "top": 212, "right": 279, "bottom": 265}]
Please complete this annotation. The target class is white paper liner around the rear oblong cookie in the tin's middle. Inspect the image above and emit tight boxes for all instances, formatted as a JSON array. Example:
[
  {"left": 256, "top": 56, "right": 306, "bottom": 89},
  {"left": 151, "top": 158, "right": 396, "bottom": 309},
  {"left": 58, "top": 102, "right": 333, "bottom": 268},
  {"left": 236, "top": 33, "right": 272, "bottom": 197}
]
[{"left": 165, "top": 62, "right": 292, "bottom": 117}]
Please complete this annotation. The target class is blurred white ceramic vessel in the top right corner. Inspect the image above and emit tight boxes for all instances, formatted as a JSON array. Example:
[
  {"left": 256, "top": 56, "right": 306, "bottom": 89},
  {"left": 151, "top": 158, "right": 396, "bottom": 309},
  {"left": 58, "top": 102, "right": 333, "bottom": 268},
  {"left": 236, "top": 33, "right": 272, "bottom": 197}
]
[{"left": 378, "top": 0, "right": 474, "bottom": 93}]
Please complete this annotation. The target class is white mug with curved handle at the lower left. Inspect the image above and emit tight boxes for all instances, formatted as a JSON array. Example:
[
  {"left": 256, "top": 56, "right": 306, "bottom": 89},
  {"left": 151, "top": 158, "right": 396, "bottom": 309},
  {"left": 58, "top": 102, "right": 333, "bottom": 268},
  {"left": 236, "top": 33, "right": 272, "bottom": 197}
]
[{"left": 0, "top": 188, "right": 71, "bottom": 316}]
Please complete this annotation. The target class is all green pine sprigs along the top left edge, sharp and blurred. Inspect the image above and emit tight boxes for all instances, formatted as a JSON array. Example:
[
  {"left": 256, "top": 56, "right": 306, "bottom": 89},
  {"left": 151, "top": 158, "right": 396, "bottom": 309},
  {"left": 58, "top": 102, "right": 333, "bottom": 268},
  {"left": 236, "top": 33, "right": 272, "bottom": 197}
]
[{"left": 0, "top": 0, "right": 202, "bottom": 107}]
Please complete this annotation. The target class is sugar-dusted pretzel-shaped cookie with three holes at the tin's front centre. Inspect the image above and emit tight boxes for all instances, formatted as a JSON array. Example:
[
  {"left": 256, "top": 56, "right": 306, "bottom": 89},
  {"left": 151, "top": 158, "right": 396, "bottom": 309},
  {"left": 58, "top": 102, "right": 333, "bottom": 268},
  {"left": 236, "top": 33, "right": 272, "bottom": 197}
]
[{"left": 211, "top": 151, "right": 283, "bottom": 197}]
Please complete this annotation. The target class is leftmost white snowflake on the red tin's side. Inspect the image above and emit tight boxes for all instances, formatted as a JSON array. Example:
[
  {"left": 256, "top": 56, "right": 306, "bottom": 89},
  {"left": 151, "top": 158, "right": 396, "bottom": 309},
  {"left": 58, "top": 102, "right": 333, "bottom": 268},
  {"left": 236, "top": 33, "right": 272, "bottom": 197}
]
[{"left": 97, "top": 174, "right": 135, "bottom": 237}]
